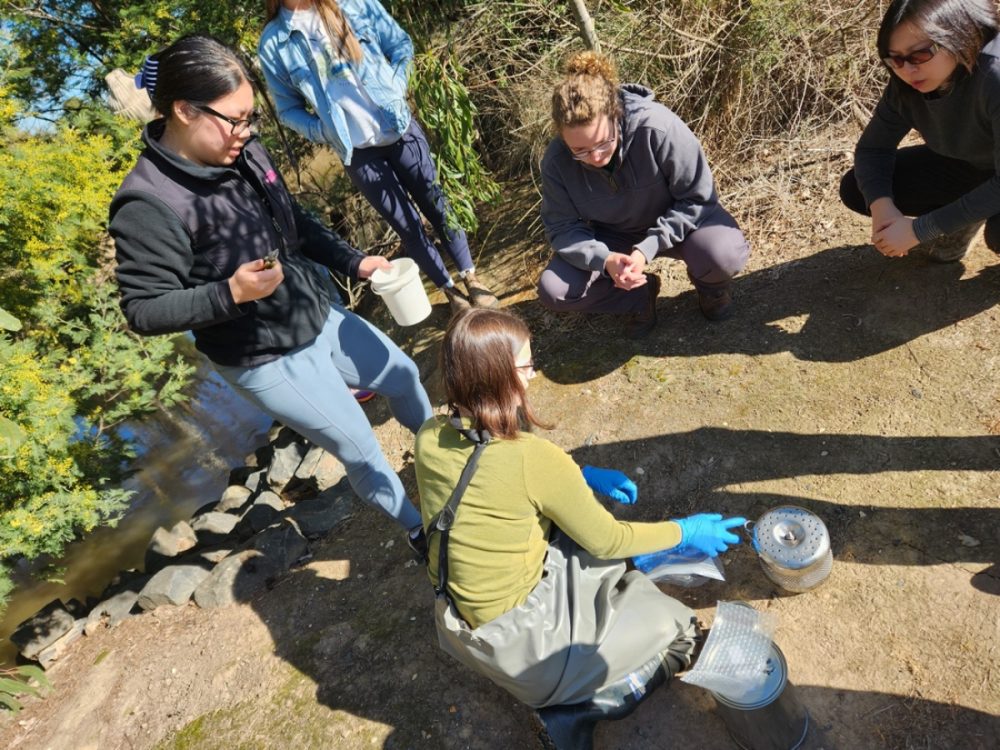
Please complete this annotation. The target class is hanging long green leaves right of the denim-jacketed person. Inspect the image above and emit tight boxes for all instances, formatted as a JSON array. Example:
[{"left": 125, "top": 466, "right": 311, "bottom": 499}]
[{"left": 410, "top": 52, "right": 500, "bottom": 232}]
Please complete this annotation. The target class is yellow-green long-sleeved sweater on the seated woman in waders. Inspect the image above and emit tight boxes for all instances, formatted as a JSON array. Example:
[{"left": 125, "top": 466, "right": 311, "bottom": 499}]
[{"left": 416, "top": 417, "right": 681, "bottom": 628}]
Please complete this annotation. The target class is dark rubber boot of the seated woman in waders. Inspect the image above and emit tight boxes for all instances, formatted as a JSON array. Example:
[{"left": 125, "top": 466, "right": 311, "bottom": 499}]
[{"left": 535, "top": 654, "right": 672, "bottom": 750}]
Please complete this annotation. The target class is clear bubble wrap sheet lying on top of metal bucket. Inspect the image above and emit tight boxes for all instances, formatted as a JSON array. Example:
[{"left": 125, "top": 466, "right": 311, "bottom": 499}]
[{"left": 681, "top": 602, "right": 778, "bottom": 701}]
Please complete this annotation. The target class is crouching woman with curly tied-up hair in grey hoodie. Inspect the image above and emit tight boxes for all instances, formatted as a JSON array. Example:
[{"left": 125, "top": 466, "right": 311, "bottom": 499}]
[{"left": 538, "top": 52, "right": 750, "bottom": 337}]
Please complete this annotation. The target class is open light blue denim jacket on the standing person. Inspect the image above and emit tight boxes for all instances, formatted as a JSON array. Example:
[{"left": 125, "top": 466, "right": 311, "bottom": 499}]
[{"left": 257, "top": 0, "right": 413, "bottom": 164}]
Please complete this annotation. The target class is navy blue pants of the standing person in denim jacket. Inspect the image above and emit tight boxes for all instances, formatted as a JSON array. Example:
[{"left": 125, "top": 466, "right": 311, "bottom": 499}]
[{"left": 344, "top": 120, "right": 473, "bottom": 287}]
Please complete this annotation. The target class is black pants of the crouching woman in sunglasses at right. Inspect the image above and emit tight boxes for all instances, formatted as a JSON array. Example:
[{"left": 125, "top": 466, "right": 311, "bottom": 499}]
[{"left": 840, "top": 146, "right": 1000, "bottom": 253}]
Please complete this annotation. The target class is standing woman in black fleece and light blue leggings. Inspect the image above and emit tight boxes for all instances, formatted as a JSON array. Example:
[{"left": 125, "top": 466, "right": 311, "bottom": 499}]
[{"left": 109, "top": 35, "right": 431, "bottom": 546}]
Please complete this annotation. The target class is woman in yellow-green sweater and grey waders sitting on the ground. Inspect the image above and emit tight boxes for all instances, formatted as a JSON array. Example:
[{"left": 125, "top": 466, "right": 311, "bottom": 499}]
[{"left": 416, "top": 309, "right": 744, "bottom": 750}]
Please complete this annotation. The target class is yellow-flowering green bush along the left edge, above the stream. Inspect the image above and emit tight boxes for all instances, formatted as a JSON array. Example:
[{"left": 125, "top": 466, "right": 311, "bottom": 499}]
[{"left": 0, "top": 58, "right": 192, "bottom": 608}]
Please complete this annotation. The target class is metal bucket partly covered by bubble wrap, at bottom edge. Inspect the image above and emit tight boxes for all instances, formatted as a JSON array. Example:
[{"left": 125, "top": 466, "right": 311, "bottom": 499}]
[{"left": 709, "top": 643, "right": 809, "bottom": 750}]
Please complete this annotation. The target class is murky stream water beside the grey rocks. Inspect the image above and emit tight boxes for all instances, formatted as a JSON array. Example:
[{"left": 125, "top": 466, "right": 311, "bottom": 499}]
[{"left": 0, "top": 360, "right": 271, "bottom": 666}]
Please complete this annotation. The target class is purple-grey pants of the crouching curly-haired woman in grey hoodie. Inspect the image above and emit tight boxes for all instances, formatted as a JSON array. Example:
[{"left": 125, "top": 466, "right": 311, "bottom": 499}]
[{"left": 538, "top": 206, "right": 750, "bottom": 314}]
